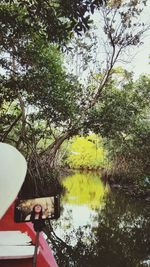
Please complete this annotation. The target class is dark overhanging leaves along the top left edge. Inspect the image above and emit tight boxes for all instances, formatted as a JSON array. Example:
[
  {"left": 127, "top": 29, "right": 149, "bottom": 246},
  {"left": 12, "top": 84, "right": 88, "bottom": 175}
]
[{"left": 0, "top": 0, "right": 103, "bottom": 43}]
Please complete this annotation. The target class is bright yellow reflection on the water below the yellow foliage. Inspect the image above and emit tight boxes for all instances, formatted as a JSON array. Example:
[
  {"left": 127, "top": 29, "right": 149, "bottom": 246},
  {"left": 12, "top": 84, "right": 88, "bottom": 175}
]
[{"left": 62, "top": 173, "right": 109, "bottom": 209}]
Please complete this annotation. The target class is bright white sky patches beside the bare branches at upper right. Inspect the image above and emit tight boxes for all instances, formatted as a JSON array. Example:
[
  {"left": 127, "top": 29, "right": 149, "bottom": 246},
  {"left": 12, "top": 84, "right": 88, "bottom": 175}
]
[{"left": 66, "top": 0, "right": 150, "bottom": 83}]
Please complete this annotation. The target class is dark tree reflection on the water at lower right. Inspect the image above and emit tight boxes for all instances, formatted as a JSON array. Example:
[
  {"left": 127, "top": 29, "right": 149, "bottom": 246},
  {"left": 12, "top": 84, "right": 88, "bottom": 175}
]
[{"left": 47, "top": 194, "right": 150, "bottom": 267}]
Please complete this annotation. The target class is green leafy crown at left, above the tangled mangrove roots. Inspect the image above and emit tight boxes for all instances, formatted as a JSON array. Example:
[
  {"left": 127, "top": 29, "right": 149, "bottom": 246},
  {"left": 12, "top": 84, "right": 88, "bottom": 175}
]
[{"left": 0, "top": 47, "right": 80, "bottom": 142}]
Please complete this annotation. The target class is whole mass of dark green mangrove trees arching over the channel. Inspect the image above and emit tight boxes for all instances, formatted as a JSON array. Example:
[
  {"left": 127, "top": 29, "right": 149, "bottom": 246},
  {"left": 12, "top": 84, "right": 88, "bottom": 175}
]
[{"left": 0, "top": 0, "right": 150, "bottom": 195}]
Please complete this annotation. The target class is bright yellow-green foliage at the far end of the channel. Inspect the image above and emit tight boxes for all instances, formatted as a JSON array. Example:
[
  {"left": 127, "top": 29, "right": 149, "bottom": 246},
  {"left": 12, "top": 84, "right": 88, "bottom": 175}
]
[{"left": 66, "top": 134, "right": 106, "bottom": 169}]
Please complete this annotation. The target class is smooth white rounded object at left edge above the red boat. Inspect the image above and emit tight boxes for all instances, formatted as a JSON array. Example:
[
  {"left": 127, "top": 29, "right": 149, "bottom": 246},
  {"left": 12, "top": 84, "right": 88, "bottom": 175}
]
[{"left": 0, "top": 142, "right": 27, "bottom": 219}]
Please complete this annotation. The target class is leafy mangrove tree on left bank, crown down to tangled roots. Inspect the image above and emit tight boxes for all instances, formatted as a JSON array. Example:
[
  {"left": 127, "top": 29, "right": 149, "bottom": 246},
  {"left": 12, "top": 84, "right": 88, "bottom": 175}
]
[{"left": 0, "top": 40, "right": 77, "bottom": 197}]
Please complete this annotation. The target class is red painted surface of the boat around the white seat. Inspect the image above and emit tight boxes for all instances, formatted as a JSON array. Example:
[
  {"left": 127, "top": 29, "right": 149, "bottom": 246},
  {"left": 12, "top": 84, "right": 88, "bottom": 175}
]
[{"left": 0, "top": 205, "right": 58, "bottom": 267}]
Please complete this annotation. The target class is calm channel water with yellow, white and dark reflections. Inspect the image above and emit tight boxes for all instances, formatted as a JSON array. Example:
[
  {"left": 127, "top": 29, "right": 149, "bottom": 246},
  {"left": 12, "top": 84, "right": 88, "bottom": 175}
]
[{"left": 51, "top": 173, "right": 150, "bottom": 267}]
